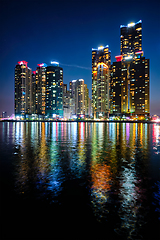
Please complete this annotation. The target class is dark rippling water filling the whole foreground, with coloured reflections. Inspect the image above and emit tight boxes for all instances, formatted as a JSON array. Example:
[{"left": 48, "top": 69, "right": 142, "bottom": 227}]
[{"left": 0, "top": 122, "right": 160, "bottom": 239}]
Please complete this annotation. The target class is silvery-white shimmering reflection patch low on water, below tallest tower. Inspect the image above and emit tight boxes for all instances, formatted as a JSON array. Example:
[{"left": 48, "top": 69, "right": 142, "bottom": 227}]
[{"left": 115, "top": 164, "right": 143, "bottom": 238}]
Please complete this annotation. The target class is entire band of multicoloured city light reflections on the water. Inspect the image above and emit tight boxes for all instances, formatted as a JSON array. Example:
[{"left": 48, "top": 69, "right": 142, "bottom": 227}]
[{"left": 0, "top": 122, "right": 160, "bottom": 239}]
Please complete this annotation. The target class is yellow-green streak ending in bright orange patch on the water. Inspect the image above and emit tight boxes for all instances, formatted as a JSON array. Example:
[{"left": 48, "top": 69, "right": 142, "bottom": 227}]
[{"left": 90, "top": 123, "right": 112, "bottom": 221}]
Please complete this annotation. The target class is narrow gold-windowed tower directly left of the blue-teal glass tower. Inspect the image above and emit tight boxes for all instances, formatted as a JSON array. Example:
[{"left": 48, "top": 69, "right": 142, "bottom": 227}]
[{"left": 35, "top": 63, "right": 47, "bottom": 115}]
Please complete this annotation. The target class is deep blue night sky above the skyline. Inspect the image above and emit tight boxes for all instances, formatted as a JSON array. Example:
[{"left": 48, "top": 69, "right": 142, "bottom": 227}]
[{"left": 0, "top": 0, "right": 160, "bottom": 115}]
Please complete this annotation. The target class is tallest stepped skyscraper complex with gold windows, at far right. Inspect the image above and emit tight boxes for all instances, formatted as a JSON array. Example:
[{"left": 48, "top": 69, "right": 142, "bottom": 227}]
[{"left": 110, "top": 20, "right": 150, "bottom": 115}]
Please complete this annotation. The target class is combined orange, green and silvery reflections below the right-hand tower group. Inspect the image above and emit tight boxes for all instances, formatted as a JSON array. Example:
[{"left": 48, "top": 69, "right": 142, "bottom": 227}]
[{"left": 91, "top": 123, "right": 149, "bottom": 238}]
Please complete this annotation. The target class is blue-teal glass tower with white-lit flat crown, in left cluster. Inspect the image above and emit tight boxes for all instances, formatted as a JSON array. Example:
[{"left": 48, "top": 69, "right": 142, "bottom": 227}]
[{"left": 45, "top": 62, "right": 63, "bottom": 118}]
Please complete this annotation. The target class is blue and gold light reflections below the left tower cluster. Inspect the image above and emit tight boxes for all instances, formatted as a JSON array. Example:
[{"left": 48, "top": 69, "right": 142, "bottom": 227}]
[{"left": 15, "top": 122, "right": 65, "bottom": 201}]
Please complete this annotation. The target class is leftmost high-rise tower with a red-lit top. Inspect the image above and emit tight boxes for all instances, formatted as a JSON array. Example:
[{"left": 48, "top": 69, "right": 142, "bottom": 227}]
[{"left": 14, "top": 61, "right": 32, "bottom": 117}]
